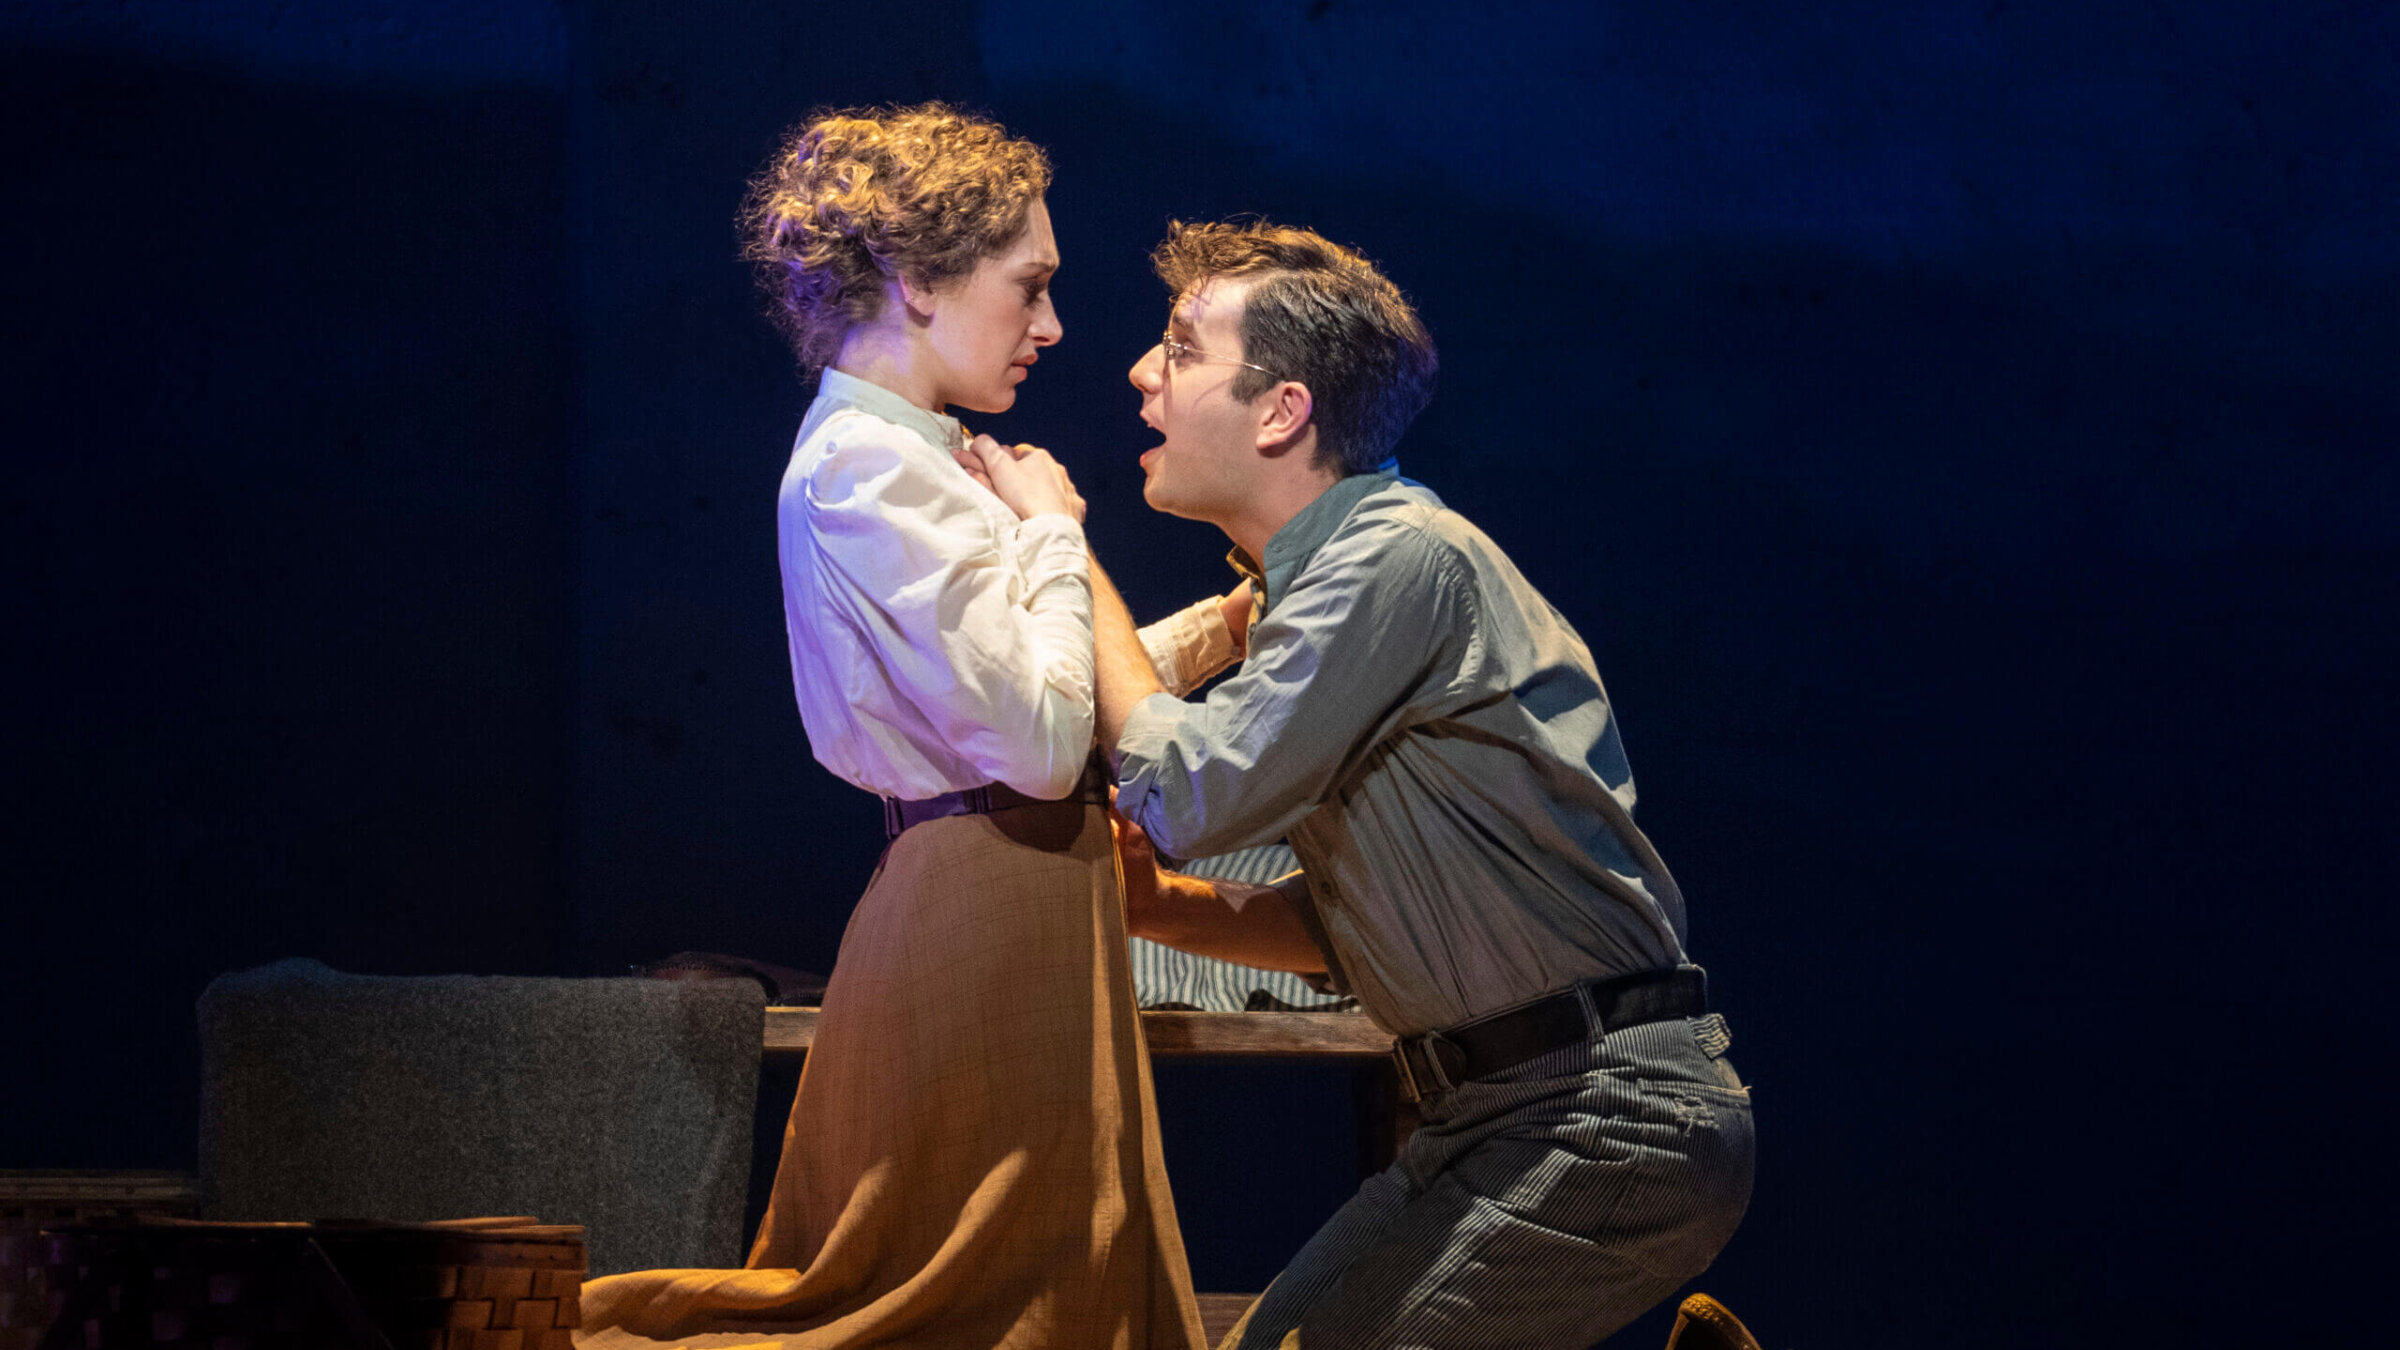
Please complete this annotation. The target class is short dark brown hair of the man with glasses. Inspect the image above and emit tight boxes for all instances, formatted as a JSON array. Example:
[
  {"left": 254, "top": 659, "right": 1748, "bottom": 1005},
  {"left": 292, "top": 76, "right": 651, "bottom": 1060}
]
[{"left": 1150, "top": 221, "right": 1440, "bottom": 478}]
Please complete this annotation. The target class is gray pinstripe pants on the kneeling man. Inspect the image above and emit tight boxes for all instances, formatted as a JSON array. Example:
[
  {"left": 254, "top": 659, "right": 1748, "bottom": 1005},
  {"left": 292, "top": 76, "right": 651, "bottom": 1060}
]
[{"left": 1224, "top": 1014, "right": 1752, "bottom": 1350}]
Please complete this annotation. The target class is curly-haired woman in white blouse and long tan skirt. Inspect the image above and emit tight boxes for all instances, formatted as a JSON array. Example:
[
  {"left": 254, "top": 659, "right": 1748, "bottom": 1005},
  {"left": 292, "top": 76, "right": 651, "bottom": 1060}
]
[{"left": 583, "top": 103, "right": 1246, "bottom": 1350}]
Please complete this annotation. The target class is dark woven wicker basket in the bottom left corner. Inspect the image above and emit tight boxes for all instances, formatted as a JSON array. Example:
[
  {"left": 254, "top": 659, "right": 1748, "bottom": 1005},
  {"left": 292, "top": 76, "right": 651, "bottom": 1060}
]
[{"left": 46, "top": 1218, "right": 586, "bottom": 1350}]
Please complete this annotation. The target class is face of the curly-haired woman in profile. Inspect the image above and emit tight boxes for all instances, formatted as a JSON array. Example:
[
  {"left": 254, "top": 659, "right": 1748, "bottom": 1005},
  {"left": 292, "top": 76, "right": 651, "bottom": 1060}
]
[{"left": 926, "top": 199, "right": 1063, "bottom": 413}]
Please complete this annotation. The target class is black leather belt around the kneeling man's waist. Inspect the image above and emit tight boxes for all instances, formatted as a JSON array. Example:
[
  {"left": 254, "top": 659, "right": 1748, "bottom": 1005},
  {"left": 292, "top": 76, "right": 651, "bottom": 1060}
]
[{"left": 1392, "top": 966, "right": 1709, "bottom": 1103}]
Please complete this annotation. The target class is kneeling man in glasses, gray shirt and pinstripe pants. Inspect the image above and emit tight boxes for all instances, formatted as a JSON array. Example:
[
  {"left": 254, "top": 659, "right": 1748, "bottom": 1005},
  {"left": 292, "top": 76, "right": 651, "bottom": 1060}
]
[{"left": 1094, "top": 223, "right": 1752, "bottom": 1350}]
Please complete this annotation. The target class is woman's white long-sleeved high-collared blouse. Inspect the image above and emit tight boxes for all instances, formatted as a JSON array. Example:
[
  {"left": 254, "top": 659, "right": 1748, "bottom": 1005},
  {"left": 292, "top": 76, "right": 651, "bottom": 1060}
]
[{"left": 778, "top": 370, "right": 1234, "bottom": 800}]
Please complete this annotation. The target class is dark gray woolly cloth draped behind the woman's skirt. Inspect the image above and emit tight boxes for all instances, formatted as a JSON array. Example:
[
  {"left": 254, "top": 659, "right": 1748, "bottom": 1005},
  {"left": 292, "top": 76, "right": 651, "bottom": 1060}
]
[{"left": 199, "top": 961, "right": 766, "bottom": 1276}]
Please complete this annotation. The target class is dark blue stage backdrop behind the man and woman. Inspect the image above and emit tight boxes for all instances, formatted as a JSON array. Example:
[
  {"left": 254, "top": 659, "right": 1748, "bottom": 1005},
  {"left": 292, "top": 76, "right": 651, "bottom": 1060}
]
[{"left": 0, "top": 0, "right": 2400, "bottom": 1348}]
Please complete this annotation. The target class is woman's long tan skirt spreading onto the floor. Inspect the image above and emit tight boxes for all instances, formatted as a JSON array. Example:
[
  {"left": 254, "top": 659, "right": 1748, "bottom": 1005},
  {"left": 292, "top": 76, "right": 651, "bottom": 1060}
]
[{"left": 576, "top": 805, "right": 1202, "bottom": 1350}]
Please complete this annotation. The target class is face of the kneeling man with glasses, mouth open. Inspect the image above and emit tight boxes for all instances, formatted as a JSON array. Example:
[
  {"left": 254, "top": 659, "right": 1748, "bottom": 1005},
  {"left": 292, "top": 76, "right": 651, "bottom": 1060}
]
[{"left": 1128, "top": 276, "right": 1267, "bottom": 526}]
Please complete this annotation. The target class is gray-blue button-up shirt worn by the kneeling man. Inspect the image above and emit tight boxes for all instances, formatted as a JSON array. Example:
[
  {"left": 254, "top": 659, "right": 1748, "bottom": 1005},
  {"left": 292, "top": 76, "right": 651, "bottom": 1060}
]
[{"left": 1116, "top": 471, "right": 1685, "bottom": 1035}]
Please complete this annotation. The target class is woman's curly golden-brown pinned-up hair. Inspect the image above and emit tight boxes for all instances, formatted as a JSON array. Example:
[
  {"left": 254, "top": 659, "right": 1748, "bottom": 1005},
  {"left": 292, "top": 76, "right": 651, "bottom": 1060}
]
[{"left": 742, "top": 103, "right": 1049, "bottom": 375}]
